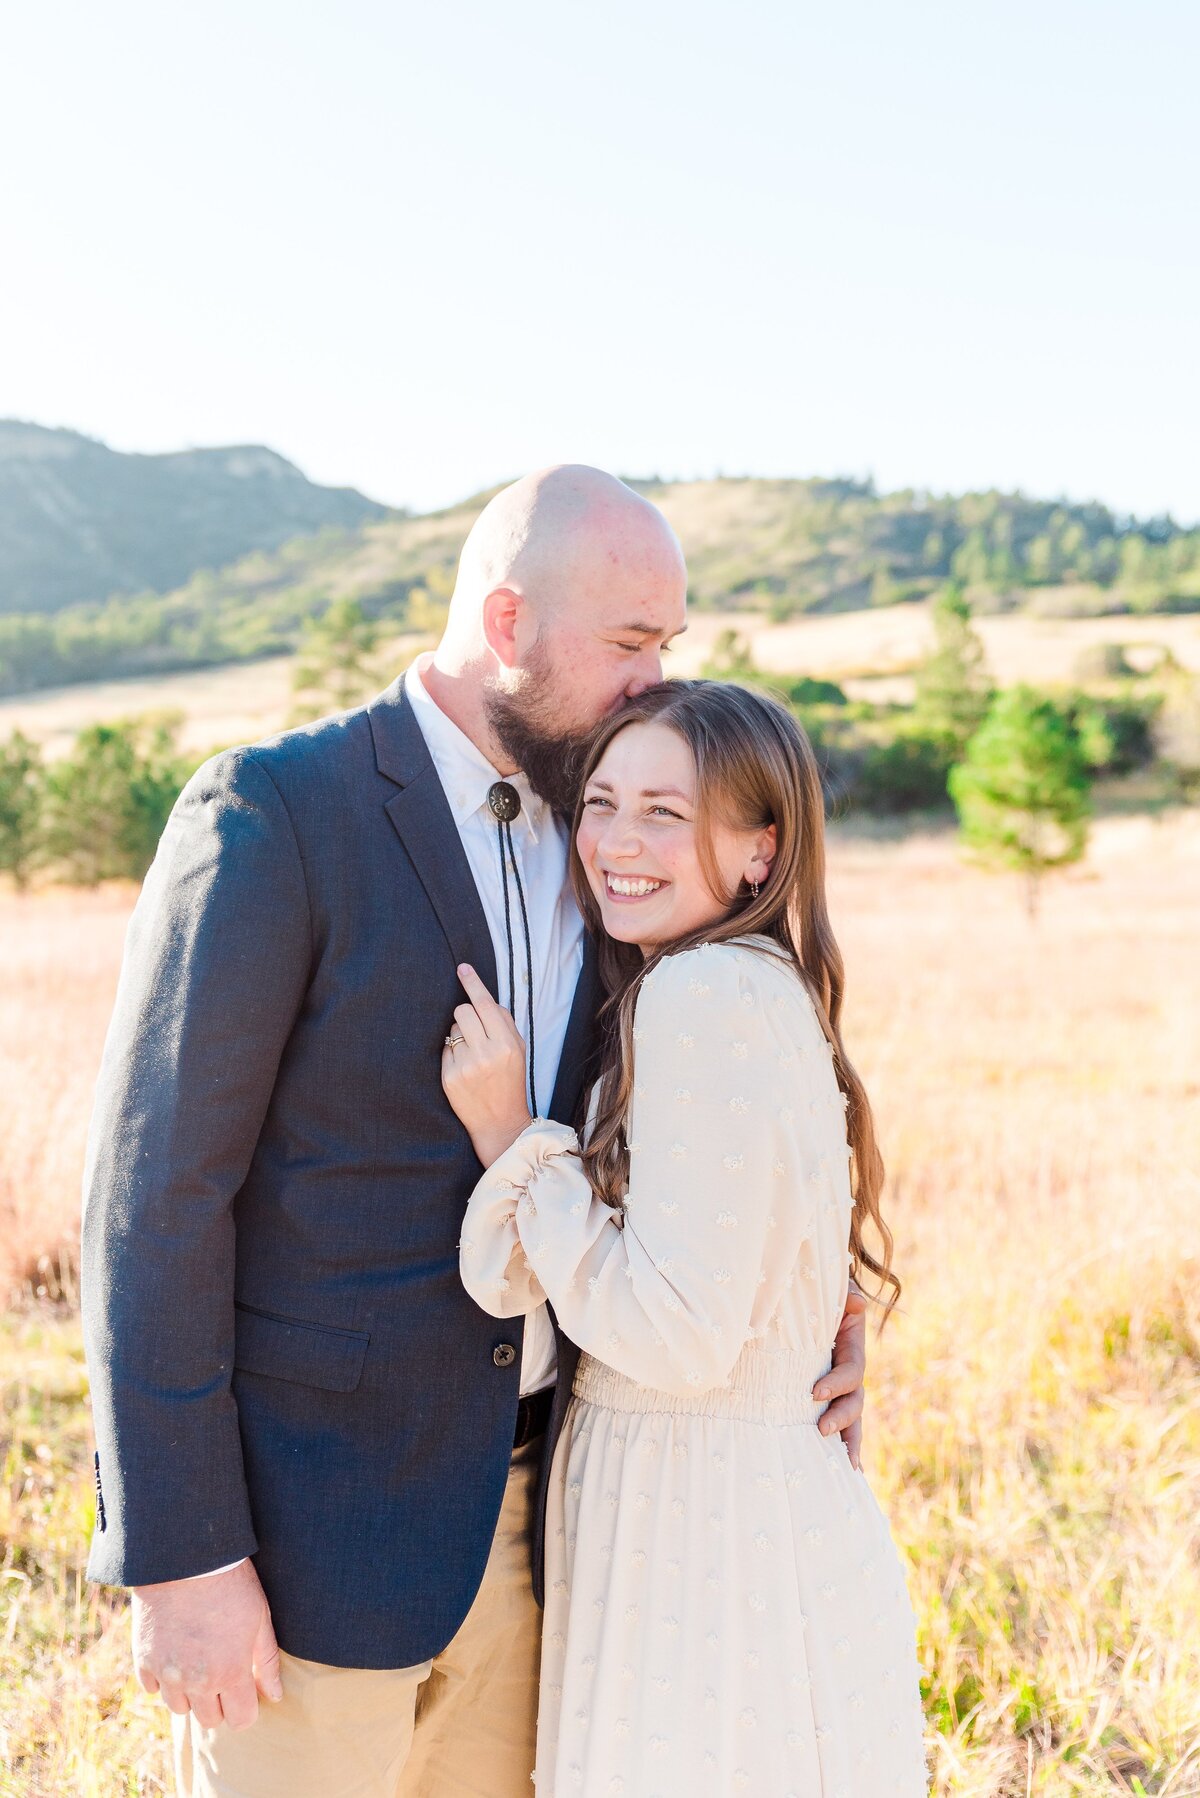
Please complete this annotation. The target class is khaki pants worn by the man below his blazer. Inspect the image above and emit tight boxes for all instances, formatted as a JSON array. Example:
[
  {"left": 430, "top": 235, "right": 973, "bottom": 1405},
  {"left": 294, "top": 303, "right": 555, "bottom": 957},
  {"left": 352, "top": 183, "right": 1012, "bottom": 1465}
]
[{"left": 173, "top": 1442, "right": 542, "bottom": 1798}]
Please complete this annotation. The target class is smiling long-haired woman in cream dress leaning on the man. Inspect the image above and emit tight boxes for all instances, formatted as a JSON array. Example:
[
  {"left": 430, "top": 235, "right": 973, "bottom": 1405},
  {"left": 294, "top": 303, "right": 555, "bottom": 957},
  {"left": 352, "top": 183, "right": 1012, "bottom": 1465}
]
[{"left": 443, "top": 681, "right": 927, "bottom": 1798}]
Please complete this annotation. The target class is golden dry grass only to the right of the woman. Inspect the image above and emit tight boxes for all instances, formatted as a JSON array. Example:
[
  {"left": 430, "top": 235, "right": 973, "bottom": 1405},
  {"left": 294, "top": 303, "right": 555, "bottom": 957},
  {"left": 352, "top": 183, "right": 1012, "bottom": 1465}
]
[{"left": 835, "top": 820, "right": 1200, "bottom": 1798}]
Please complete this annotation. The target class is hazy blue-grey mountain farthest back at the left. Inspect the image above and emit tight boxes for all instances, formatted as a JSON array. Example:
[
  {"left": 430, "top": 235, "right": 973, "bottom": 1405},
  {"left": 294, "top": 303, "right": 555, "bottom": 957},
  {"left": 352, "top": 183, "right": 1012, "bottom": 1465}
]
[{"left": 0, "top": 419, "right": 385, "bottom": 613}]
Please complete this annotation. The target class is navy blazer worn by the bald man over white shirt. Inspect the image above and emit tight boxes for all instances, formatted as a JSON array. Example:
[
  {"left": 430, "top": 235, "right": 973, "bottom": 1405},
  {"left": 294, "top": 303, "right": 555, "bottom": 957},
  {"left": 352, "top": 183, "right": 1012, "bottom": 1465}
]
[{"left": 83, "top": 683, "right": 599, "bottom": 1667}]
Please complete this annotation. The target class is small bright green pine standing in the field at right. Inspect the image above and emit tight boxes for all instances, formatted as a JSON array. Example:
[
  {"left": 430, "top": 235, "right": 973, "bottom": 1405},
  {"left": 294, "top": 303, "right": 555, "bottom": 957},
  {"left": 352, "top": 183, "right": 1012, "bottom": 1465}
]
[{"left": 948, "top": 687, "right": 1090, "bottom": 917}]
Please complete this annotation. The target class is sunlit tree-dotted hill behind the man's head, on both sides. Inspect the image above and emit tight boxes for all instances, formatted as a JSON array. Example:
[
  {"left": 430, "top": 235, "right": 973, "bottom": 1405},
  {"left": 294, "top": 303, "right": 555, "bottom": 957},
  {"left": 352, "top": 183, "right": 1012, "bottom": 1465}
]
[{"left": 0, "top": 478, "right": 1200, "bottom": 694}]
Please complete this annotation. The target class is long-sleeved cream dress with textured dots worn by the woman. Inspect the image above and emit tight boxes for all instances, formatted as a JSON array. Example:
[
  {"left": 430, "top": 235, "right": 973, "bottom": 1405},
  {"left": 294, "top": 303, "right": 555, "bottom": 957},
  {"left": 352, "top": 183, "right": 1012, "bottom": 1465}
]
[{"left": 461, "top": 939, "right": 927, "bottom": 1798}]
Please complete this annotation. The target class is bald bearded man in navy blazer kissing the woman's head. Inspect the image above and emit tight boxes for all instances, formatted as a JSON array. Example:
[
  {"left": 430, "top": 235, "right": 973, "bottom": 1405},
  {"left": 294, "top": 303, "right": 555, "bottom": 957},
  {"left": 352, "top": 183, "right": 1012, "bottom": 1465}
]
[{"left": 85, "top": 466, "right": 874, "bottom": 1798}]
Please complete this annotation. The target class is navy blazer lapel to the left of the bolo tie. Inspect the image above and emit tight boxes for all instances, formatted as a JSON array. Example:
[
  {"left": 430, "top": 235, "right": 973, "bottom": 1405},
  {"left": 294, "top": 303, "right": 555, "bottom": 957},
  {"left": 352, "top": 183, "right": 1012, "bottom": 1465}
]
[{"left": 367, "top": 681, "right": 497, "bottom": 992}]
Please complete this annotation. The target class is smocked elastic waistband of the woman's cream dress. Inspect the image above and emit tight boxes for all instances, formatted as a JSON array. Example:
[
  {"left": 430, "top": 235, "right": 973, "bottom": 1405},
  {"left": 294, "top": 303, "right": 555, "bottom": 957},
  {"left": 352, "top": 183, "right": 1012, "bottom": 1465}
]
[{"left": 572, "top": 1343, "right": 829, "bottom": 1426}]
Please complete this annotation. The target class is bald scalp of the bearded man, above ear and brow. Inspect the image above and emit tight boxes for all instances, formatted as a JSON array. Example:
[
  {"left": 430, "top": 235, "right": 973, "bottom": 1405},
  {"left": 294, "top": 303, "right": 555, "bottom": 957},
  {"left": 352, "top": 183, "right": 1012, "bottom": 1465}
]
[{"left": 448, "top": 462, "right": 687, "bottom": 642}]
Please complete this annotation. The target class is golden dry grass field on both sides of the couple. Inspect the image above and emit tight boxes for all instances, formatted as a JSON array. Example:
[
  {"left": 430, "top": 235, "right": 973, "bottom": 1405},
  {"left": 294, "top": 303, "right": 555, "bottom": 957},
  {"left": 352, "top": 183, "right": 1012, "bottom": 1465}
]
[{"left": 0, "top": 813, "right": 1200, "bottom": 1798}]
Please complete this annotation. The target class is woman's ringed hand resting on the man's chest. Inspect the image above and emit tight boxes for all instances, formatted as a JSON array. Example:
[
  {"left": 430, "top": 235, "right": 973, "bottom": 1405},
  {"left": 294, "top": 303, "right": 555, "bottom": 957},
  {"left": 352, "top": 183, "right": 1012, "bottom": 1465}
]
[{"left": 441, "top": 962, "right": 533, "bottom": 1167}]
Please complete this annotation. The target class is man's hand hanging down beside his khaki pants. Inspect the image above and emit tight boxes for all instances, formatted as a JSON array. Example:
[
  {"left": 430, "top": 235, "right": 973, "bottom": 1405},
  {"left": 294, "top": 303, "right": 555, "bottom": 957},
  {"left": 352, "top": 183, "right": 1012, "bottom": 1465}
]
[{"left": 133, "top": 1561, "right": 282, "bottom": 1730}]
